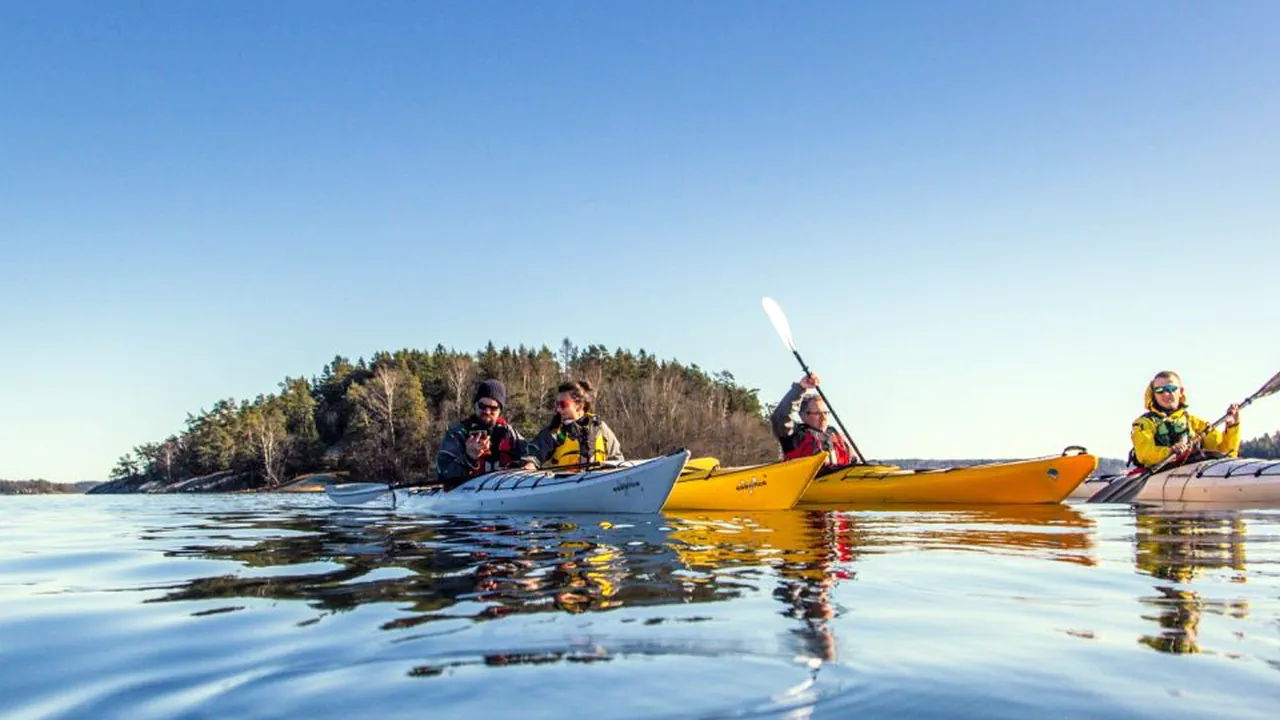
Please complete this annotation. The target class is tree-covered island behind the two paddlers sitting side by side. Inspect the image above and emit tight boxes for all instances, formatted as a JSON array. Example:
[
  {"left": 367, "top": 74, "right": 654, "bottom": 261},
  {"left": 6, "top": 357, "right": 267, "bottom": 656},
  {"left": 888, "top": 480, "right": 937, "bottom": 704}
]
[{"left": 102, "top": 338, "right": 780, "bottom": 492}]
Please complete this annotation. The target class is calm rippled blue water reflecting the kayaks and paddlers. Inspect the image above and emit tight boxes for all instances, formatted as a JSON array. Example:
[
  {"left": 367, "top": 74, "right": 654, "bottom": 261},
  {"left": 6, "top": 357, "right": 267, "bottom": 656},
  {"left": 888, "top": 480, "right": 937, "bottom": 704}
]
[{"left": 0, "top": 495, "right": 1280, "bottom": 720}]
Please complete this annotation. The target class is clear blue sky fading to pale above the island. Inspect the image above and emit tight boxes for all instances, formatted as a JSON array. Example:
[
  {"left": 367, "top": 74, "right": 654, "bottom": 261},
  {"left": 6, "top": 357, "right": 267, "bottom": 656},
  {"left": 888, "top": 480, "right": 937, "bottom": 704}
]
[{"left": 0, "top": 0, "right": 1280, "bottom": 480}]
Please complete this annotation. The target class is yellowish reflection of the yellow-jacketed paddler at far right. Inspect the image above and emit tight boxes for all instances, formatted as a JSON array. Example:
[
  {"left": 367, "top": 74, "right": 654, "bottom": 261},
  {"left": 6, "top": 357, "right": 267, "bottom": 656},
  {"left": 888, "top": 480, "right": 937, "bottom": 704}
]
[{"left": 1135, "top": 505, "right": 1249, "bottom": 655}]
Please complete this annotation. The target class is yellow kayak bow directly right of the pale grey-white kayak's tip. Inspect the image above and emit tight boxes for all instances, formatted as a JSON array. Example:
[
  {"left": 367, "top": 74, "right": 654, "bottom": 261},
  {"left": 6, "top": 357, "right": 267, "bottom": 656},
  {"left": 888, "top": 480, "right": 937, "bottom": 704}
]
[{"left": 662, "top": 452, "right": 827, "bottom": 510}]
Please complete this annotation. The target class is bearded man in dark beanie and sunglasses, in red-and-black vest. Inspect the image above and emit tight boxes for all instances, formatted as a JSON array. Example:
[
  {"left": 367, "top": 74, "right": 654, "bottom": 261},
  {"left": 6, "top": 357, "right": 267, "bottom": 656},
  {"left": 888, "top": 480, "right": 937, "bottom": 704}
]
[{"left": 435, "top": 379, "right": 535, "bottom": 489}]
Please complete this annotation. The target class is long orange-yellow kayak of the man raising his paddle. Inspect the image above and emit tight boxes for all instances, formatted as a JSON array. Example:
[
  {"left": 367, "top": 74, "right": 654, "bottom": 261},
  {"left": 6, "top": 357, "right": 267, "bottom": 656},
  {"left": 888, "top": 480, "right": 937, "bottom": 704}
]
[{"left": 798, "top": 446, "right": 1098, "bottom": 506}]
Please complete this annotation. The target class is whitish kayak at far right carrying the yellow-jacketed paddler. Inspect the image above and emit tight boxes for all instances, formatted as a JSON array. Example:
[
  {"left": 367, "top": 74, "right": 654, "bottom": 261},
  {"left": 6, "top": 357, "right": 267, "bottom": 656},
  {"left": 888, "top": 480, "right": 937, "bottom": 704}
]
[{"left": 1068, "top": 457, "right": 1280, "bottom": 503}]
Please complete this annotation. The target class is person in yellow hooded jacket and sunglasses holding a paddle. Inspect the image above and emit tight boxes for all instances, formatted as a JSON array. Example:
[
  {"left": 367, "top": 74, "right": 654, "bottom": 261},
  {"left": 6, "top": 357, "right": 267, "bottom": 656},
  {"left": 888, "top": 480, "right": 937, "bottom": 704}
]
[{"left": 1129, "top": 370, "right": 1240, "bottom": 468}]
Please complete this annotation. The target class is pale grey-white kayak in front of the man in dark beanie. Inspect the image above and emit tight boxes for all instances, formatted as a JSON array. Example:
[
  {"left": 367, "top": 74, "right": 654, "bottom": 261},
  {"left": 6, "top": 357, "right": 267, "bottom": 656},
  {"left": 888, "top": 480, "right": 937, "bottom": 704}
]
[{"left": 396, "top": 450, "right": 689, "bottom": 514}]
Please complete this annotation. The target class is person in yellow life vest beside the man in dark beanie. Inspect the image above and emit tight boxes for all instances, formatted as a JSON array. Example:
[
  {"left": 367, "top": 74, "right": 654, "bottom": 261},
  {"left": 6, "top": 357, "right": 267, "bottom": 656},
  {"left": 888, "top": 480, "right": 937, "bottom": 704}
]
[{"left": 529, "top": 380, "right": 623, "bottom": 468}]
